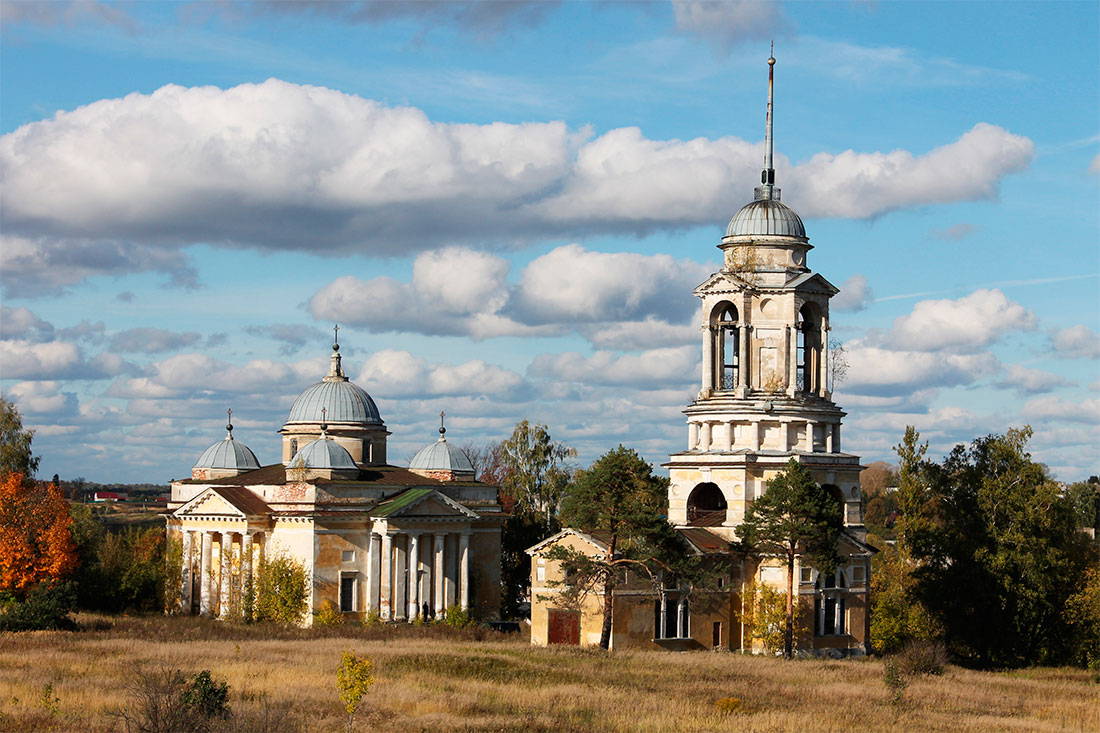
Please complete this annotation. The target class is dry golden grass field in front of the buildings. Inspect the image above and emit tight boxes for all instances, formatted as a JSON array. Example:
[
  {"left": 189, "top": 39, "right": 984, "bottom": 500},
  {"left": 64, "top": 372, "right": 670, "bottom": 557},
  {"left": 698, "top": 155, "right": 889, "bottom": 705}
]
[{"left": 0, "top": 616, "right": 1100, "bottom": 733}]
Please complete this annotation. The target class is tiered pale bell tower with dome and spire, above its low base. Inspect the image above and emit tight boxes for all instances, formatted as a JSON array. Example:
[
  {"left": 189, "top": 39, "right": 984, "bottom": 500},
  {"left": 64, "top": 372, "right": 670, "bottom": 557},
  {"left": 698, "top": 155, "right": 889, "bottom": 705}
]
[{"left": 666, "top": 51, "right": 866, "bottom": 539}]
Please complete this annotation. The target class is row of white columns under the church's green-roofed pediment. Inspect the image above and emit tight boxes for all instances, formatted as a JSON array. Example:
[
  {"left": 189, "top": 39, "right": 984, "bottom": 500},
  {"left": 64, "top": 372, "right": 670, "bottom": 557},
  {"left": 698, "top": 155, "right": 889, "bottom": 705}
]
[{"left": 366, "top": 529, "right": 472, "bottom": 622}]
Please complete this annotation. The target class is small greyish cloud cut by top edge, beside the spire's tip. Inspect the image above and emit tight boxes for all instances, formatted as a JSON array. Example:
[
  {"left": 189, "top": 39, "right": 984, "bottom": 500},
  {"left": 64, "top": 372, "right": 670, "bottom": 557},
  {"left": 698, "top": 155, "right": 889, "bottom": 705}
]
[{"left": 672, "top": 0, "right": 788, "bottom": 52}]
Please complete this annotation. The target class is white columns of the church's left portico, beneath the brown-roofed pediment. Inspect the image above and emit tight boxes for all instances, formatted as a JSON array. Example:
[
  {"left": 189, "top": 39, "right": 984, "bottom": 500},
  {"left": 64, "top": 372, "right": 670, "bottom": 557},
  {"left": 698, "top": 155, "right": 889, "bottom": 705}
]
[{"left": 179, "top": 529, "right": 263, "bottom": 616}]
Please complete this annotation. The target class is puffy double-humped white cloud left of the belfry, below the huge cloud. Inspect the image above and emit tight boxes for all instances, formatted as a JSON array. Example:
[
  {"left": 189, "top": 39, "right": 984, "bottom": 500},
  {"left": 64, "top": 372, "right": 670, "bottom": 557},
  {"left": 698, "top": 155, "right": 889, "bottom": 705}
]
[{"left": 309, "top": 244, "right": 708, "bottom": 338}]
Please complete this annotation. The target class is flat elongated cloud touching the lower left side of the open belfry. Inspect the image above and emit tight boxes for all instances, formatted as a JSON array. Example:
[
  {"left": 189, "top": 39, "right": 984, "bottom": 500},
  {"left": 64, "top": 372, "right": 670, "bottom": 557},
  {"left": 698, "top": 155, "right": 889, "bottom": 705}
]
[{"left": 527, "top": 347, "right": 699, "bottom": 387}]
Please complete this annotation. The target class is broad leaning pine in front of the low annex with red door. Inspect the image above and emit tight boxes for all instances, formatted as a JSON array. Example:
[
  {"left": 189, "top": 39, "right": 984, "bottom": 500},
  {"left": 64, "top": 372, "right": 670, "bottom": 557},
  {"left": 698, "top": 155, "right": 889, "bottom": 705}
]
[{"left": 547, "top": 446, "right": 686, "bottom": 649}]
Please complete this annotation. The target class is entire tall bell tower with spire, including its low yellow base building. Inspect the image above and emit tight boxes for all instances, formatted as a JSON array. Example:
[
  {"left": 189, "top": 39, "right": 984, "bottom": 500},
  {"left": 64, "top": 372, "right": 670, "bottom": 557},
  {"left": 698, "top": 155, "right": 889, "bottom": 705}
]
[{"left": 528, "top": 58, "right": 875, "bottom": 654}]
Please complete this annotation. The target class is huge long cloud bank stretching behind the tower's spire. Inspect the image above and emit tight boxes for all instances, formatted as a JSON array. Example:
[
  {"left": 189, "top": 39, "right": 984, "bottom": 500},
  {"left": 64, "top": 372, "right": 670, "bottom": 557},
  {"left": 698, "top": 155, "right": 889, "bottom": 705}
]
[{"left": 0, "top": 79, "right": 1034, "bottom": 294}]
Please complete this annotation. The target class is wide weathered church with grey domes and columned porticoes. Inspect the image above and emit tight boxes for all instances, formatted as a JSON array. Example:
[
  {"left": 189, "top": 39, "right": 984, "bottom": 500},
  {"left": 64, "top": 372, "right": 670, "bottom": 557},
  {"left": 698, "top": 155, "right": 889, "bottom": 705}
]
[{"left": 167, "top": 334, "right": 504, "bottom": 625}]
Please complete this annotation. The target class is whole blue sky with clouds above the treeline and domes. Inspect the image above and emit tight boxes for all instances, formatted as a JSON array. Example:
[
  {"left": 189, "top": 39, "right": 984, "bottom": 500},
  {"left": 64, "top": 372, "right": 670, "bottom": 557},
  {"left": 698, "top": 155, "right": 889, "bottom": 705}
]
[{"left": 0, "top": 0, "right": 1100, "bottom": 481}]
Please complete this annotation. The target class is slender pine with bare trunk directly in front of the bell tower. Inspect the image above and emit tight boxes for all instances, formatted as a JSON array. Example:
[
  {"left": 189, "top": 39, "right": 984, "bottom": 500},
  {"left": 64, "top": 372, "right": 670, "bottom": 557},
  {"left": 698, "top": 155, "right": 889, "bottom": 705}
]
[{"left": 738, "top": 458, "right": 844, "bottom": 659}]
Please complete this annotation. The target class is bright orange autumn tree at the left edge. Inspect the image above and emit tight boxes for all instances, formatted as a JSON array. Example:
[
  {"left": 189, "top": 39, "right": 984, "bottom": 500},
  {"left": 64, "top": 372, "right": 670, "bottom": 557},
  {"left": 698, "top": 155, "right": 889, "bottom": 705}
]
[{"left": 0, "top": 473, "right": 77, "bottom": 598}]
